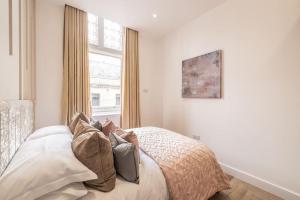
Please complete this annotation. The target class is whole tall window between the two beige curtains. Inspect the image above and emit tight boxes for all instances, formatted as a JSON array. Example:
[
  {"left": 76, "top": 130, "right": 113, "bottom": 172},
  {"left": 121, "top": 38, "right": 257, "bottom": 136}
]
[{"left": 88, "top": 14, "right": 123, "bottom": 125}]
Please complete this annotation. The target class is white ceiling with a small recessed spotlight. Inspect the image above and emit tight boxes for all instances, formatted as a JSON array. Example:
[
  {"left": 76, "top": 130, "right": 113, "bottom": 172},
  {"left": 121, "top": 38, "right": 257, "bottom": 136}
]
[{"left": 55, "top": 0, "right": 225, "bottom": 38}]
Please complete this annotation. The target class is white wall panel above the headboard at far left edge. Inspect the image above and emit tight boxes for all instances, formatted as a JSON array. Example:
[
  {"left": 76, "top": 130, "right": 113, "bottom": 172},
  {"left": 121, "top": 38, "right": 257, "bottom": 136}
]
[{"left": 0, "top": 0, "right": 19, "bottom": 100}]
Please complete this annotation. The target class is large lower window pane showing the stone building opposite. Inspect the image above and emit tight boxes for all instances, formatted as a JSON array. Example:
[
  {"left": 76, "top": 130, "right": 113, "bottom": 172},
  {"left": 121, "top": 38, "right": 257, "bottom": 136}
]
[{"left": 89, "top": 53, "right": 121, "bottom": 116}]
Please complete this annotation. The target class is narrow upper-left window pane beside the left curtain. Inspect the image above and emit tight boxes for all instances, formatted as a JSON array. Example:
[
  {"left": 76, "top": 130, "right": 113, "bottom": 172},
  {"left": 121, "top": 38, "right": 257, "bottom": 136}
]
[{"left": 88, "top": 13, "right": 99, "bottom": 45}]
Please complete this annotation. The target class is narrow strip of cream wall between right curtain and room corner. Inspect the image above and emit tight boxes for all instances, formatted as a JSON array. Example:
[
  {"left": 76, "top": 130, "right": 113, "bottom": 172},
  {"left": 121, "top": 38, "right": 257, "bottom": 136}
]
[{"left": 139, "top": 36, "right": 163, "bottom": 127}]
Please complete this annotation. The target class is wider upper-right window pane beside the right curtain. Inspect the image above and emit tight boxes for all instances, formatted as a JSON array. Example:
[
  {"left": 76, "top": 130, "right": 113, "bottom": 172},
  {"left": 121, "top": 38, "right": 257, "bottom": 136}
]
[{"left": 104, "top": 19, "right": 123, "bottom": 51}]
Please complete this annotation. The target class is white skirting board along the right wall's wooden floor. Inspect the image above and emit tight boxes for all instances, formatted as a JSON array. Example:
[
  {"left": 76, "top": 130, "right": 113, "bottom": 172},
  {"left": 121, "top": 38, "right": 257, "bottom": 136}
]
[{"left": 220, "top": 163, "right": 300, "bottom": 200}]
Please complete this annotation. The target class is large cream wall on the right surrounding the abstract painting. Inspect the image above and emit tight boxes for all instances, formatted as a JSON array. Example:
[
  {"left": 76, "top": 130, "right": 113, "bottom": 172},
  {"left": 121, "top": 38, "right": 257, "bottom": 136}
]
[{"left": 160, "top": 0, "right": 300, "bottom": 199}]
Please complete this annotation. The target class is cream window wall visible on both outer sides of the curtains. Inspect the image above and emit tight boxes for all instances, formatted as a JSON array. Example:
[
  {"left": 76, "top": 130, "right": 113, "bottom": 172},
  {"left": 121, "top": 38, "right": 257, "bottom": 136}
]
[{"left": 36, "top": 0, "right": 162, "bottom": 128}]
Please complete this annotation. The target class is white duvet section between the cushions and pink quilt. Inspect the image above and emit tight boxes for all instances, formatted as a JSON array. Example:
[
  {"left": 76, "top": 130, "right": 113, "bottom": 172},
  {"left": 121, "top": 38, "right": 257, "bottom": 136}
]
[{"left": 81, "top": 151, "right": 169, "bottom": 200}]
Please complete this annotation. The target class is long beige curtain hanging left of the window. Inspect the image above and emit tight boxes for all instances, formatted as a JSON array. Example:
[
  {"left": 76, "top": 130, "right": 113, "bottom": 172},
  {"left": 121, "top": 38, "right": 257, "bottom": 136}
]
[{"left": 62, "top": 5, "right": 91, "bottom": 124}]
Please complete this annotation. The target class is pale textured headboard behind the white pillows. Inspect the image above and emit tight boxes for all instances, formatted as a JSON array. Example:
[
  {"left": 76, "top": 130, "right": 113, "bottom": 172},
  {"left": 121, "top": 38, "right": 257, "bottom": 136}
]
[{"left": 0, "top": 100, "right": 33, "bottom": 176}]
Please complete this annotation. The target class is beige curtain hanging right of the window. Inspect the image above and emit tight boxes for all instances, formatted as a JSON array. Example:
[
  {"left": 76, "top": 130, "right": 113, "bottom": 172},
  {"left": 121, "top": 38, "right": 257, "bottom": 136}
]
[{"left": 121, "top": 28, "right": 141, "bottom": 128}]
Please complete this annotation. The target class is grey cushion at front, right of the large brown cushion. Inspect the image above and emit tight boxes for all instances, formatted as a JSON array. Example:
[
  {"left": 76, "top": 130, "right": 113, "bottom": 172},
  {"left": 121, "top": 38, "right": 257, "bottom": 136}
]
[{"left": 109, "top": 133, "right": 139, "bottom": 183}]
